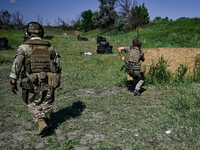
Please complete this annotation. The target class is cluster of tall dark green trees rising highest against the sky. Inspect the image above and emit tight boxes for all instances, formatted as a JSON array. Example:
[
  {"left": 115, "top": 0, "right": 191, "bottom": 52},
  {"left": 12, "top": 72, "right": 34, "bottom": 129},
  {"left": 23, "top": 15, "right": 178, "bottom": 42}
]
[{"left": 81, "top": 0, "right": 150, "bottom": 32}]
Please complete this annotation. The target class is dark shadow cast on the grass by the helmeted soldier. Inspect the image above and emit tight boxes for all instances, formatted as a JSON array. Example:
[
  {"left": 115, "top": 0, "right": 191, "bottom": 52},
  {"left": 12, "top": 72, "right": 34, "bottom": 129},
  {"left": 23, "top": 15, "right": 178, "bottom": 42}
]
[{"left": 50, "top": 101, "right": 86, "bottom": 135}]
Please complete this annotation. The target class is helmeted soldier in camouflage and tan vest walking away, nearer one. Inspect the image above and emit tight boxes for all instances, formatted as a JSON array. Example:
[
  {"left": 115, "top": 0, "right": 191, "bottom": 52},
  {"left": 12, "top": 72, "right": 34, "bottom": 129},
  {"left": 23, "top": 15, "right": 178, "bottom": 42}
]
[{"left": 10, "top": 22, "right": 61, "bottom": 136}]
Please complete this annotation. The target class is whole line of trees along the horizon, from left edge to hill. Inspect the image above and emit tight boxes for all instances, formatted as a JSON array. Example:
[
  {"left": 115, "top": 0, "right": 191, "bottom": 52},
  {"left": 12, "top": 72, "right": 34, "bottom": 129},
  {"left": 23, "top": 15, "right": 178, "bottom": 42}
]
[{"left": 0, "top": 0, "right": 150, "bottom": 32}]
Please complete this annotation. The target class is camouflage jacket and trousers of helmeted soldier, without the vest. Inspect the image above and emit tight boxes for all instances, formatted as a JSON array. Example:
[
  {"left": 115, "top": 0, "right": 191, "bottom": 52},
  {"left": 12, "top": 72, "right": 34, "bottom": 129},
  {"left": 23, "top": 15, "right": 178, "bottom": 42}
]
[{"left": 10, "top": 37, "right": 61, "bottom": 123}]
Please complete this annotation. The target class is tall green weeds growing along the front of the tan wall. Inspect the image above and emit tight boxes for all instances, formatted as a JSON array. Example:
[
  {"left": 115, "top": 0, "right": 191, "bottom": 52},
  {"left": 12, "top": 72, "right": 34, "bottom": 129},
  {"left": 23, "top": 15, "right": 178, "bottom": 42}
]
[{"left": 145, "top": 55, "right": 199, "bottom": 86}]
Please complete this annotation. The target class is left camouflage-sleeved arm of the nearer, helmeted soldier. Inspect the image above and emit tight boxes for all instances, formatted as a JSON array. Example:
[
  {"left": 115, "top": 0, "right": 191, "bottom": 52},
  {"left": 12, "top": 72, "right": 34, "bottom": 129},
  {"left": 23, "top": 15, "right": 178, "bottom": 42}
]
[{"left": 10, "top": 46, "right": 25, "bottom": 83}]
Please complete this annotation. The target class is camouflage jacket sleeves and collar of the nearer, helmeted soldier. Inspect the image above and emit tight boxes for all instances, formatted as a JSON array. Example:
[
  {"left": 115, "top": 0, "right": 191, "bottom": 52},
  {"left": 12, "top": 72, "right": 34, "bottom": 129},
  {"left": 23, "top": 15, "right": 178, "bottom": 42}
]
[{"left": 10, "top": 37, "right": 61, "bottom": 79}]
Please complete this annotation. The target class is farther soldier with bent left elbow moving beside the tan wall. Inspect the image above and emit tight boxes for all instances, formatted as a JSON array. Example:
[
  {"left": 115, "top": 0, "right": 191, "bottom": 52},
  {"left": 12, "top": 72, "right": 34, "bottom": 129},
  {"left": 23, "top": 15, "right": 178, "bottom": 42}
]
[{"left": 118, "top": 39, "right": 146, "bottom": 96}]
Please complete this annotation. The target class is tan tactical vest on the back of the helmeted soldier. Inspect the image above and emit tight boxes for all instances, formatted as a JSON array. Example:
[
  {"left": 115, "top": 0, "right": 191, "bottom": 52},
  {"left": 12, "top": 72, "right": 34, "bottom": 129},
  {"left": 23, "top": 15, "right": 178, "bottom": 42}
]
[{"left": 24, "top": 40, "right": 52, "bottom": 73}]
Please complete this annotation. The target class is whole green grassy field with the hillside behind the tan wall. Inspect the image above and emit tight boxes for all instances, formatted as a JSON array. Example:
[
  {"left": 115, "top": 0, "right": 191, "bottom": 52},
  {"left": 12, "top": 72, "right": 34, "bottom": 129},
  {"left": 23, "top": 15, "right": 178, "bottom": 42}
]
[{"left": 0, "top": 18, "right": 200, "bottom": 150}]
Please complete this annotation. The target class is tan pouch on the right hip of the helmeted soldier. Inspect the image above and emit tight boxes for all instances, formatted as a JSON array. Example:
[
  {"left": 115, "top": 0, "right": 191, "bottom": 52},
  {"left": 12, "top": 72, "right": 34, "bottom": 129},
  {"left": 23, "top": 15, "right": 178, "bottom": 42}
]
[{"left": 47, "top": 72, "right": 61, "bottom": 89}]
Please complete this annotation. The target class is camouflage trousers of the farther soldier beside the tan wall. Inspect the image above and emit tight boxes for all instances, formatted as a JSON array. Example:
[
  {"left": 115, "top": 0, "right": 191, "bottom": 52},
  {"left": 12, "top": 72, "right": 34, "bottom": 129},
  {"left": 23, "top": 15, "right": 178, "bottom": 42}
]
[{"left": 131, "top": 71, "right": 145, "bottom": 91}]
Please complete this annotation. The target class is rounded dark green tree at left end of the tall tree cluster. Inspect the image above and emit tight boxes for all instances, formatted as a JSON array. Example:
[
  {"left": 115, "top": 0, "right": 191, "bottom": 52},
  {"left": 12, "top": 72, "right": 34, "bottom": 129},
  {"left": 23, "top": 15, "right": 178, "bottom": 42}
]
[{"left": 81, "top": 10, "right": 94, "bottom": 32}]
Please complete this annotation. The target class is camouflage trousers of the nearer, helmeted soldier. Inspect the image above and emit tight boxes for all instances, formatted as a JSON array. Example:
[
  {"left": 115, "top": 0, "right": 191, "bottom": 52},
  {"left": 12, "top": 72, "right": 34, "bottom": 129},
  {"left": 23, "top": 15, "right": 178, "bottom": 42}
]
[{"left": 28, "top": 84, "right": 54, "bottom": 123}]
